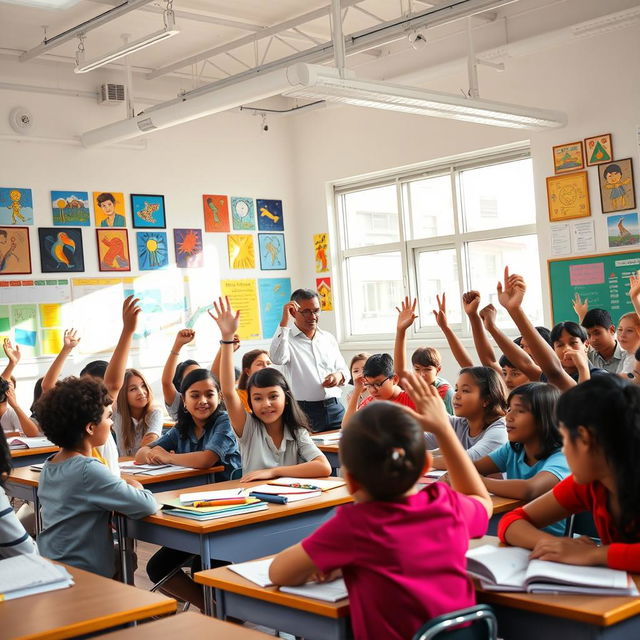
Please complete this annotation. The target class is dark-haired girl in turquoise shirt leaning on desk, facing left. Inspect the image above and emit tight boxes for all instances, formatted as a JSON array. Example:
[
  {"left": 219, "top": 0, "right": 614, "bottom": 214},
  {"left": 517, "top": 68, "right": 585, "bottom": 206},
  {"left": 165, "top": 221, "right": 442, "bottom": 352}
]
[{"left": 474, "top": 382, "right": 569, "bottom": 536}]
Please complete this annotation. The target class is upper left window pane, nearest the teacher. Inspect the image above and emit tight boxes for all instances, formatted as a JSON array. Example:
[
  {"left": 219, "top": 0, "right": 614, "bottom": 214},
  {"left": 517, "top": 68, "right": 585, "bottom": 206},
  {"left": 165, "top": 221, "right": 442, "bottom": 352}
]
[{"left": 344, "top": 185, "right": 400, "bottom": 248}]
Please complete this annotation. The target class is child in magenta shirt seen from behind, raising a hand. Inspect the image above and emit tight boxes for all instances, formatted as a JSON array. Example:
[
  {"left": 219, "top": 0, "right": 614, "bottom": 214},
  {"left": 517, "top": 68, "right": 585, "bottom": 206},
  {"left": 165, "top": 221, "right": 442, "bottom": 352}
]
[{"left": 269, "top": 373, "right": 492, "bottom": 640}]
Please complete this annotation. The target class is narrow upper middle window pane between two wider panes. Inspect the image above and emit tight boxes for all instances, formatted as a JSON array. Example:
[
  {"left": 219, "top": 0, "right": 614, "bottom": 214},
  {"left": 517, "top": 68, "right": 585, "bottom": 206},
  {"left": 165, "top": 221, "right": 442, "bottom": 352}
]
[{"left": 407, "top": 175, "right": 454, "bottom": 238}]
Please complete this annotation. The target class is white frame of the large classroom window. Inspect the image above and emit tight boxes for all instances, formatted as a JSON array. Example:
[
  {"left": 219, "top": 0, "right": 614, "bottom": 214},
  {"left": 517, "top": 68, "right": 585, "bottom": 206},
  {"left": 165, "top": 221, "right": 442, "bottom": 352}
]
[{"left": 328, "top": 142, "right": 537, "bottom": 348}]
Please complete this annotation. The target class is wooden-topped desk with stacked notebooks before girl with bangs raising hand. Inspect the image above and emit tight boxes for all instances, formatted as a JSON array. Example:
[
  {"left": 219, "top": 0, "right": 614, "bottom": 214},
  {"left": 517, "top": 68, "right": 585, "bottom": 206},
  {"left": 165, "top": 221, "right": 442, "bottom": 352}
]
[{"left": 118, "top": 480, "right": 352, "bottom": 614}]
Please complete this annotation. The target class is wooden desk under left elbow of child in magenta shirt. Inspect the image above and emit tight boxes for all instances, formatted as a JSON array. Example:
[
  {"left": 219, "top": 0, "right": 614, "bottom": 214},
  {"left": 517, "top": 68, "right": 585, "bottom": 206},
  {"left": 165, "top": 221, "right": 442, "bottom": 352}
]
[{"left": 195, "top": 556, "right": 351, "bottom": 640}]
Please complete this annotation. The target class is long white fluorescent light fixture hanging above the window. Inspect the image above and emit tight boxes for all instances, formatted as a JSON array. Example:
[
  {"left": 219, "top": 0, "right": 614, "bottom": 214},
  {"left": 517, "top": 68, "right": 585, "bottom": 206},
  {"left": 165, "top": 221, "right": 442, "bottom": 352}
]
[{"left": 283, "top": 64, "right": 567, "bottom": 129}]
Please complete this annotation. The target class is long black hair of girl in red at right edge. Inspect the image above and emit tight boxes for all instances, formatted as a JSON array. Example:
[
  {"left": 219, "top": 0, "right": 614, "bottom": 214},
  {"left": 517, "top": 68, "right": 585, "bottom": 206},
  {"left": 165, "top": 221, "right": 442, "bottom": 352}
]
[{"left": 556, "top": 376, "right": 640, "bottom": 542}]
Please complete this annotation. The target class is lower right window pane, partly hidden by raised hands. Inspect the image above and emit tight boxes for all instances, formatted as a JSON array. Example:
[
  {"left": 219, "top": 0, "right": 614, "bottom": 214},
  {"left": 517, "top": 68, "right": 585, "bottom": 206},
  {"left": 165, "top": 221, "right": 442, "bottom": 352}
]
[{"left": 467, "top": 235, "right": 543, "bottom": 328}]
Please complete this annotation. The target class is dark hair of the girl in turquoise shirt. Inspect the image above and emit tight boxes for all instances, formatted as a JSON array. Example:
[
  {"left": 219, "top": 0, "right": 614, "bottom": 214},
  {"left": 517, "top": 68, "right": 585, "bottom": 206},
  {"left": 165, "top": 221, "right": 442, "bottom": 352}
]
[{"left": 507, "top": 382, "right": 562, "bottom": 460}]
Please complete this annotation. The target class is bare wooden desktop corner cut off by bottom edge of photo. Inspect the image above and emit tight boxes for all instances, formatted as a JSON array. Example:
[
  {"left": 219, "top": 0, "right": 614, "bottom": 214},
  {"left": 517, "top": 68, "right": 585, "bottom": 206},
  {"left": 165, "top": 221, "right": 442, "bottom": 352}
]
[{"left": 98, "top": 611, "right": 273, "bottom": 640}]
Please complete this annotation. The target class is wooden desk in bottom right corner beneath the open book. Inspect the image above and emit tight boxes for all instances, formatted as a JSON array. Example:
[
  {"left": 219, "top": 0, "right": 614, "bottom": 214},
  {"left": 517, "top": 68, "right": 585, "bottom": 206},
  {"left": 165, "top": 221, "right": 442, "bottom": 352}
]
[{"left": 470, "top": 536, "right": 640, "bottom": 640}]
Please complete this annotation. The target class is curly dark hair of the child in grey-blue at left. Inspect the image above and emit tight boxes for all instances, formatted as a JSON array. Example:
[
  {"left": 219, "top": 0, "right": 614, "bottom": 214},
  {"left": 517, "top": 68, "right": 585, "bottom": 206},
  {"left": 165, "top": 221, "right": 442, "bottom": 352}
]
[{"left": 35, "top": 376, "right": 112, "bottom": 449}]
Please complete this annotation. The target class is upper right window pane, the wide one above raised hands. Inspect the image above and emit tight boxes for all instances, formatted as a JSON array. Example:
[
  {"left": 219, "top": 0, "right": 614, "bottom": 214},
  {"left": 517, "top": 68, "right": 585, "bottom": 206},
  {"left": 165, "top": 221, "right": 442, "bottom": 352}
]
[{"left": 460, "top": 159, "right": 536, "bottom": 231}]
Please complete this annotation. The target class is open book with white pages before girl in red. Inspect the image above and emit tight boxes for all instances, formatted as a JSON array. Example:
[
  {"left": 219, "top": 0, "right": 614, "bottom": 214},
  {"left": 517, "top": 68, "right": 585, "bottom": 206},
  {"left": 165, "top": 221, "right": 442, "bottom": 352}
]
[{"left": 467, "top": 545, "right": 639, "bottom": 596}]
